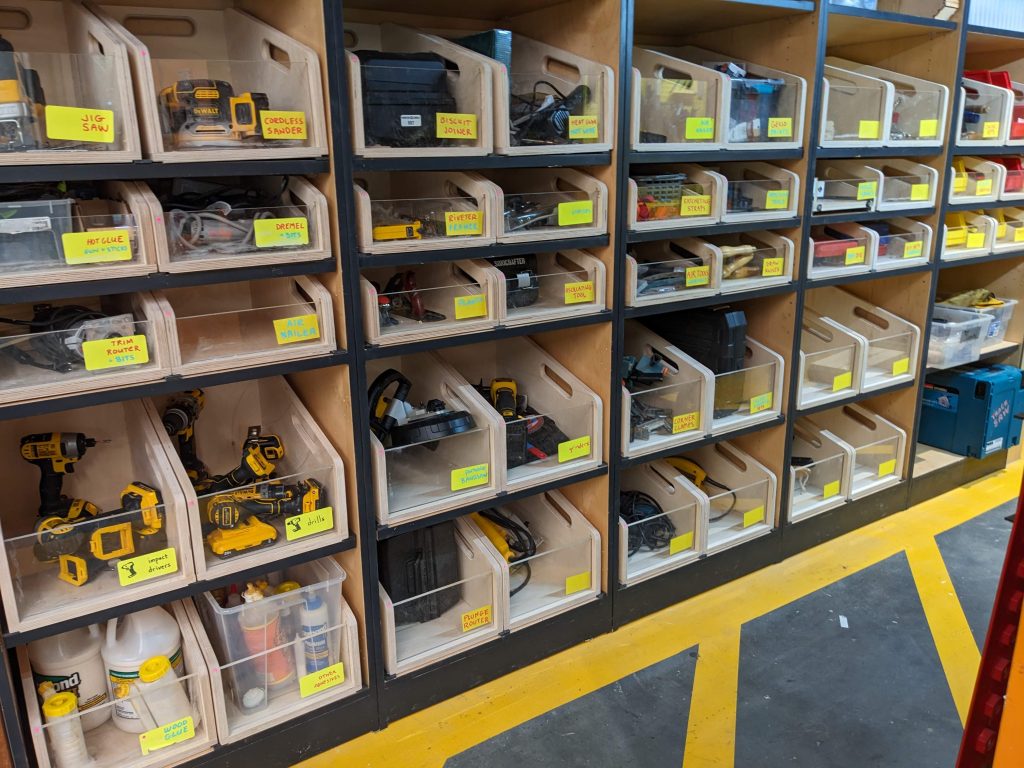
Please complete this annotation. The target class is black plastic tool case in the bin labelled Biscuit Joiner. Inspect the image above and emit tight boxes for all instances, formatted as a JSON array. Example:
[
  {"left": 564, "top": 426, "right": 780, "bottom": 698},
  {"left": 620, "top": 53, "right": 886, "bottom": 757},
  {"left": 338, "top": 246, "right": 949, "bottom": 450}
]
[{"left": 355, "top": 50, "right": 458, "bottom": 146}]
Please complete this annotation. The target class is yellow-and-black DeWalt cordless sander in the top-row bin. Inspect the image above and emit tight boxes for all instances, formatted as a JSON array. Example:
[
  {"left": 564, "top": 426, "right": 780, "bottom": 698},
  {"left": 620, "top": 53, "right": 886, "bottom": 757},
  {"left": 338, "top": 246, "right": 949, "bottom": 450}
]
[{"left": 160, "top": 80, "right": 269, "bottom": 148}]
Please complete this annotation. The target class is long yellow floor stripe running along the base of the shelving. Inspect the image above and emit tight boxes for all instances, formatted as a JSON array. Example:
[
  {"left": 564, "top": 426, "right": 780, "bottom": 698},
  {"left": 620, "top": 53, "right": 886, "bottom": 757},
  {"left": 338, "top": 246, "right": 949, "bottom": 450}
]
[{"left": 302, "top": 462, "right": 1024, "bottom": 768}]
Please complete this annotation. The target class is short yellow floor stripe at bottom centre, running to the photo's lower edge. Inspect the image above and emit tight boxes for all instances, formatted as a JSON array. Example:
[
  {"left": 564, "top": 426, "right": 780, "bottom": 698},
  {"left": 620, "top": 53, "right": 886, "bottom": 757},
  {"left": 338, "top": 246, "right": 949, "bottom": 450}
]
[{"left": 683, "top": 627, "right": 739, "bottom": 768}]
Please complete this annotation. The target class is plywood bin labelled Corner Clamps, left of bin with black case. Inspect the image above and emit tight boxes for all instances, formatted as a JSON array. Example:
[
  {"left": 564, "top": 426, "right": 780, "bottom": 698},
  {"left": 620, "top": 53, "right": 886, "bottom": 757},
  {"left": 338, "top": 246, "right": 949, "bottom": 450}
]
[{"left": 622, "top": 321, "right": 715, "bottom": 456}]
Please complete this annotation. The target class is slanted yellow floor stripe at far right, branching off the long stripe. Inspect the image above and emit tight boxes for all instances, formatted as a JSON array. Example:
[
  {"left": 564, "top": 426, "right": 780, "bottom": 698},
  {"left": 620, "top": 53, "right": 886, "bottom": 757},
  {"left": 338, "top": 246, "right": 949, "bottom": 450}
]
[{"left": 906, "top": 539, "right": 981, "bottom": 724}]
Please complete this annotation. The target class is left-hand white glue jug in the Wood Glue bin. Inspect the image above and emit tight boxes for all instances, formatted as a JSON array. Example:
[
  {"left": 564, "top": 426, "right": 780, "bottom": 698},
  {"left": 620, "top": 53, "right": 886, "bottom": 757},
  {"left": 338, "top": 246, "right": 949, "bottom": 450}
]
[{"left": 29, "top": 624, "right": 111, "bottom": 731}]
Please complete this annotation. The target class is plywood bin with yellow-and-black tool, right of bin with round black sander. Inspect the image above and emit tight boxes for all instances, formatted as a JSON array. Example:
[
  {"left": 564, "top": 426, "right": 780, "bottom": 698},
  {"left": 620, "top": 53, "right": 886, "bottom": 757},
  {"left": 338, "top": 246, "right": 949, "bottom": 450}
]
[{"left": 438, "top": 337, "right": 604, "bottom": 492}]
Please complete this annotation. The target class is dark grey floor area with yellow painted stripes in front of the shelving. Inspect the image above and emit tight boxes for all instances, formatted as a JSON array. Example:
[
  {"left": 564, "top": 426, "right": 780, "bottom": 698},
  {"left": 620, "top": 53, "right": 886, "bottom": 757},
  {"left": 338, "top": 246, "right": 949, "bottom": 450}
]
[{"left": 302, "top": 464, "right": 1021, "bottom": 768}]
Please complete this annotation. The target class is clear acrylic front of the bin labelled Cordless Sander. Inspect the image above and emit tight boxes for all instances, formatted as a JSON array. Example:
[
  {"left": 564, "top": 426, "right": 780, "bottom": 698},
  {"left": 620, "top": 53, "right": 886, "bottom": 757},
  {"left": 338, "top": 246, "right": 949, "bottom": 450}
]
[{"left": 151, "top": 58, "right": 312, "bottom": 152}]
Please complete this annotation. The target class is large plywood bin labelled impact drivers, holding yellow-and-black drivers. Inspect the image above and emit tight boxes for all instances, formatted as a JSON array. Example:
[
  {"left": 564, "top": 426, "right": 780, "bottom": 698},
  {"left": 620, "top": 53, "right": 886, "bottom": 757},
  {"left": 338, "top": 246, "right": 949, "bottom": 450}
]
[{"left": 0, "top": 400, "right": 196, "bottom": 632}]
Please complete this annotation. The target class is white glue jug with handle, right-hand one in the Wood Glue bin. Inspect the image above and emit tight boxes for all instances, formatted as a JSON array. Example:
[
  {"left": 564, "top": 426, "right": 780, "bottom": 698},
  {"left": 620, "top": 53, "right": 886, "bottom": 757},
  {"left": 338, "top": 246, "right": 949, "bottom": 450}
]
[{"left": 103, "top": 607, "right": 183, "bottom": 733}]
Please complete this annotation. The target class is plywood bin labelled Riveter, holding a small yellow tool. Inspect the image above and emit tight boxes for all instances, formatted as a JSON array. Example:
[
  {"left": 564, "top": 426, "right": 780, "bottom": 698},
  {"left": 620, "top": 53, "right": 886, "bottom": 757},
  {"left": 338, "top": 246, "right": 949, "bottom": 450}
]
[{"left": 353, "top": 171, "right": 498, "bottom": 254}]
